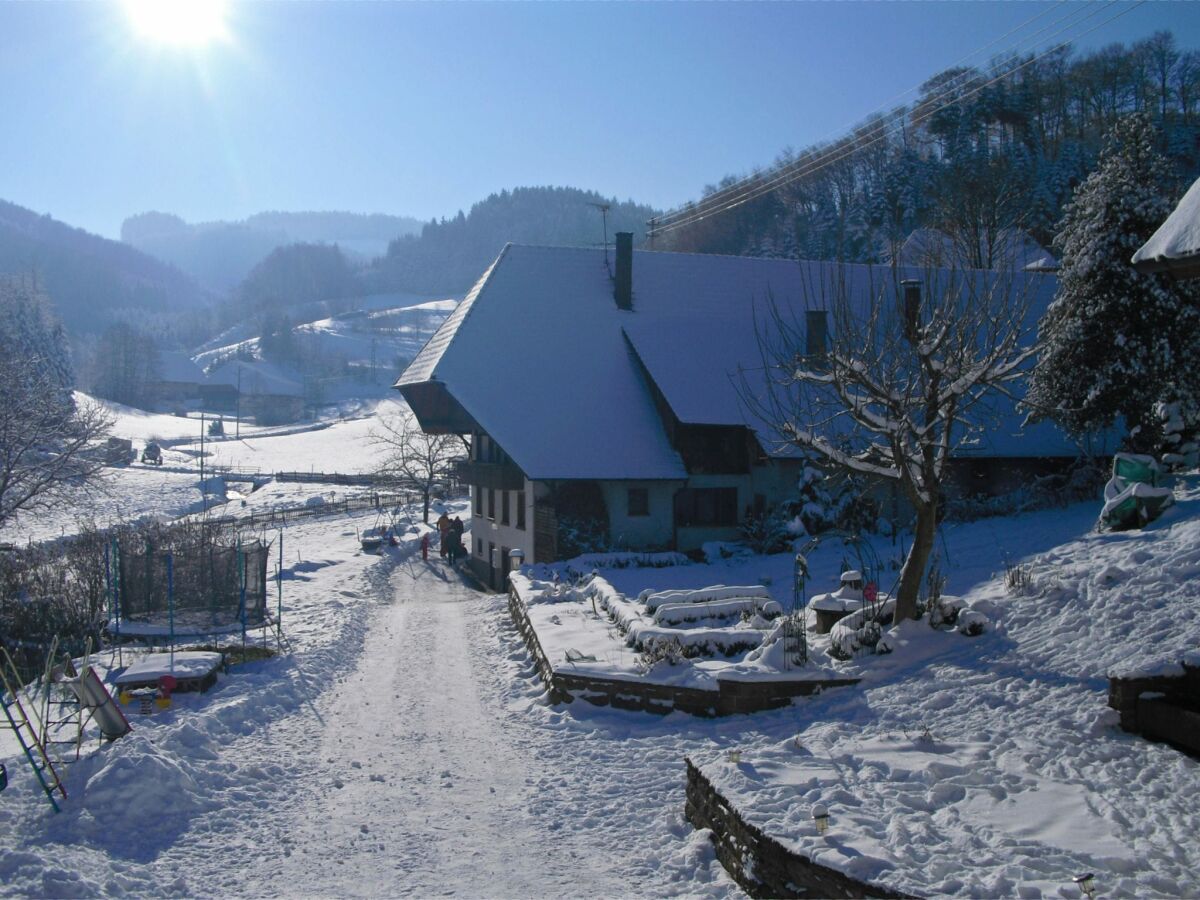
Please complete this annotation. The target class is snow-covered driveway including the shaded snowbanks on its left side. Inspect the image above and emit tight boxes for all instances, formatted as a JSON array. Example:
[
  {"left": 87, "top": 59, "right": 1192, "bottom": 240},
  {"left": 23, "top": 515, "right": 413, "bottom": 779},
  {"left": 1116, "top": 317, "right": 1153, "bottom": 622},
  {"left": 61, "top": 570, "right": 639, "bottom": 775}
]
[{"left": 0, "top": 517, "right": 729, "bottom": 898}]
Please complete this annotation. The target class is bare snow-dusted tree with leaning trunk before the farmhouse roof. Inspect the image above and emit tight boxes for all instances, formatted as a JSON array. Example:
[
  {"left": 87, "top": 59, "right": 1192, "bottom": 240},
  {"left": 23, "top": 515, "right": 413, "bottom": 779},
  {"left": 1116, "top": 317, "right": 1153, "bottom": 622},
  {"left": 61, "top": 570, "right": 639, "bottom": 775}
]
[{"left": 743, "top": 266, "right": 1038, "bottom": 622}]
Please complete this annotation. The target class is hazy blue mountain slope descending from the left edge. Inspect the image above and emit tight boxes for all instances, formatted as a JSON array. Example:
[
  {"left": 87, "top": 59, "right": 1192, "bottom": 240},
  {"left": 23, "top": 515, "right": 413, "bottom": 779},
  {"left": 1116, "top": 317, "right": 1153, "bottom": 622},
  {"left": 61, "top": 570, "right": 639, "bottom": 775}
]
[{"left": 0, "top": 200, "right": 212, "bottom": 335}]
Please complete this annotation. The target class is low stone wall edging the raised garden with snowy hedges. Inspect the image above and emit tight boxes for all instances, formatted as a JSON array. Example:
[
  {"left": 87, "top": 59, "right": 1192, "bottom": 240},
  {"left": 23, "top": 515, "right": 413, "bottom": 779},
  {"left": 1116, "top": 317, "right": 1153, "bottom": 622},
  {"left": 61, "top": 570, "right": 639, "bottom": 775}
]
[{"left": 509, "top": 587, "right": 858, "bottom": 716}]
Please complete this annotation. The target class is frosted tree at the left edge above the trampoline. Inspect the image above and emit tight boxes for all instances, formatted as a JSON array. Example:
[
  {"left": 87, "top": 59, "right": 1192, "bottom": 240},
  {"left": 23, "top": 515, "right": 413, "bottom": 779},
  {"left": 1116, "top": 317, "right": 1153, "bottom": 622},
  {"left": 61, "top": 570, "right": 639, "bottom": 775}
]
[{"left": 0, "top": 355, "right": 112, "bottom": 523}]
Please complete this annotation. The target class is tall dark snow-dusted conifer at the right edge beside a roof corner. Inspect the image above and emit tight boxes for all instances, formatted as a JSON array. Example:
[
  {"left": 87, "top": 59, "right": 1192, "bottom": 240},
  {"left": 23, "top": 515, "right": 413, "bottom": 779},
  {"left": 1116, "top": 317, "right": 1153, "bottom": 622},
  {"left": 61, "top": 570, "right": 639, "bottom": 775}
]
[{"left": 1027, "top": 114, "right": 1200, "bottom": 451}]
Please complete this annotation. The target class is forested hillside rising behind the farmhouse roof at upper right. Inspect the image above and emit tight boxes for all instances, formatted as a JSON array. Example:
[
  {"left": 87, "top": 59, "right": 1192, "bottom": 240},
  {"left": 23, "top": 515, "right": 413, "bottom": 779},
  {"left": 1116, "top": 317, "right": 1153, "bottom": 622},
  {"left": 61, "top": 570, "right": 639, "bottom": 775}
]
[{"left": 654, "top": 32, "right": 1200, "bottom": 268}]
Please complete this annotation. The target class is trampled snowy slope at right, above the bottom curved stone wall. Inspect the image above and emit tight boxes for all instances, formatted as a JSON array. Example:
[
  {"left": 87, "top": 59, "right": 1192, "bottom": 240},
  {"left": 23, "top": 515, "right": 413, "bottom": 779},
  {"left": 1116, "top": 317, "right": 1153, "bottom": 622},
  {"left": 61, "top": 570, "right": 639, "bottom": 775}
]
[{"left": 690, "top": 478, "right": 1200, "bottom": 898}]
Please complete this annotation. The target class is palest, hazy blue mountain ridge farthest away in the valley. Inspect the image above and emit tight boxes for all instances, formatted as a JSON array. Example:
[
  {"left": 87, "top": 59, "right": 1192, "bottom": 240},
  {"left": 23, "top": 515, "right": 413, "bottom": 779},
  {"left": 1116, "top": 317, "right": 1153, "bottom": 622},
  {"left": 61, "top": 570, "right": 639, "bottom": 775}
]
[{"left": 121, "top": 211, "right": 421, "bottom": 293}]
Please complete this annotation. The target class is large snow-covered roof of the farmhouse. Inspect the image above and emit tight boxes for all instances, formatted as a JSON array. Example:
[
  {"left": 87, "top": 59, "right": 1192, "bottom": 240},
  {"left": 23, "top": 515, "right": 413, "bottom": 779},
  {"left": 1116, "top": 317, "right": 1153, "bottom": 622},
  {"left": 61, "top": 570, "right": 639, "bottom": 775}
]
[{"left": 396, "top": 245, "right": 1074, "bottom": 480}]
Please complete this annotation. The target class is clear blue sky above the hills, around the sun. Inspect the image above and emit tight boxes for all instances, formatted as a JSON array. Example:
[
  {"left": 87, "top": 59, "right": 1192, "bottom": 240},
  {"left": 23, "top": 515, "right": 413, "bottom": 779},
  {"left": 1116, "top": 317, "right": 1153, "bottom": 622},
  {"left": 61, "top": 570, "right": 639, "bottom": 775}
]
[{"left": 0, "top": 2, "right": 1200, "bottom": 236}]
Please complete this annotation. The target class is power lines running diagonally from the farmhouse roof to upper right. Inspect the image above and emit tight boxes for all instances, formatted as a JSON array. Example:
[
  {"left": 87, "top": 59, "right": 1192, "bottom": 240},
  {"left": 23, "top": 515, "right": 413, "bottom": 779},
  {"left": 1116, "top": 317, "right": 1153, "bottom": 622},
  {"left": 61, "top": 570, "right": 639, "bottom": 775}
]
[{"left": 648, "top": 0, "right": 1147, "bottom": 241}]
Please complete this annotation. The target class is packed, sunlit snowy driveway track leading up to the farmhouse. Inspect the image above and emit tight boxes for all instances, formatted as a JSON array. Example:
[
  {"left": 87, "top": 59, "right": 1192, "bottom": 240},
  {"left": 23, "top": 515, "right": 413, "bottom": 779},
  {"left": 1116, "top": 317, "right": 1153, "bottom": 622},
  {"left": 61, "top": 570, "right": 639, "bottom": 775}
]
[{"left": 259, "top": 562, "right": 609, "bottom": 896}]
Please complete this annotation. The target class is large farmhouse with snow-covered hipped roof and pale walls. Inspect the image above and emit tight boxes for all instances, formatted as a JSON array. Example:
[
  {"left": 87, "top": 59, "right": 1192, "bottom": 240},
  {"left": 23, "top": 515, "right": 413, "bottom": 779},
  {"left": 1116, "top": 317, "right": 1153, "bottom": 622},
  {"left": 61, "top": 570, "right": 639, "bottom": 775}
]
[{"left": 395, "top": 234, "right": 1078, "bottom": 586}]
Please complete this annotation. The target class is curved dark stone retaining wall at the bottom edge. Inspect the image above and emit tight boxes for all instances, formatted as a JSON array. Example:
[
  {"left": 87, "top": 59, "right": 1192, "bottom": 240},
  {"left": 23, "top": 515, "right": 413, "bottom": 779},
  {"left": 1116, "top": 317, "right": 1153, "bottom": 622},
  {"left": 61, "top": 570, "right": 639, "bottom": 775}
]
[{"left": 684, "top": 758, "right": 910, "bottom": 898}]
